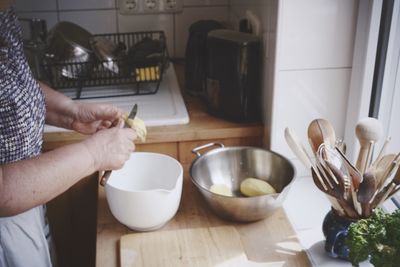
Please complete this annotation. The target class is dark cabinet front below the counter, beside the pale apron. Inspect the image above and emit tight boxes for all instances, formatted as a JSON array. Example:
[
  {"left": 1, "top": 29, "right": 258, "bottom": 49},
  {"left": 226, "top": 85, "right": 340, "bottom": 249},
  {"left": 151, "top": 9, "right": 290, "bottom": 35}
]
[{"left": 47, "top": 173, "right": 98, "bottom": 267}]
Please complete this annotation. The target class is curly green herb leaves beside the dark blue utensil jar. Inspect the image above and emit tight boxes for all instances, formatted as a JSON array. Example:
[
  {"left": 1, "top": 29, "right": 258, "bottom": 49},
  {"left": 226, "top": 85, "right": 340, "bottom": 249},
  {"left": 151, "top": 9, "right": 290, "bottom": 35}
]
[{"left": 346, "top": 209, "right": 400, "bottom": 267}]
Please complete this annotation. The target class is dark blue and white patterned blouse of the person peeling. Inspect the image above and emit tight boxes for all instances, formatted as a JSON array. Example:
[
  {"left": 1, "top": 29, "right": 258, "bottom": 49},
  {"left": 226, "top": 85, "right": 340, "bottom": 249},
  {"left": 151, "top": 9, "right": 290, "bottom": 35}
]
[{"left": 0, "top": 8, "right": 45, "bottom": 164}]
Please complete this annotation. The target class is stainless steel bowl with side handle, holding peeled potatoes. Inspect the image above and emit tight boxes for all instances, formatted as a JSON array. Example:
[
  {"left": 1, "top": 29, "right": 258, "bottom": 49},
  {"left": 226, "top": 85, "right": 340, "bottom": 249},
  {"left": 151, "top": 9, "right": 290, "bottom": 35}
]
[{"left": 190, "top": 143, "right": 295, "bottom": 222}]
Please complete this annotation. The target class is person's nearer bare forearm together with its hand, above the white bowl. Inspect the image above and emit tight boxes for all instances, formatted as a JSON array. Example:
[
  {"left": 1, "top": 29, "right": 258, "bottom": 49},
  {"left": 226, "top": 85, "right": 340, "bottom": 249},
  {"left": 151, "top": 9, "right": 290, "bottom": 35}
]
[{"left": 0, "top": 127, "right": 136, "bottom": 217}]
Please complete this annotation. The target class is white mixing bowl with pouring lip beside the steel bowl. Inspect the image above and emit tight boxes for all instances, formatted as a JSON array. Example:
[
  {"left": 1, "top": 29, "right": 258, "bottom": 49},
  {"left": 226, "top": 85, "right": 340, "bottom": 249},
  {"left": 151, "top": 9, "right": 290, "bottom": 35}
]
[{"left": 105, "top": 152, "right": 183, "bottom": 231}]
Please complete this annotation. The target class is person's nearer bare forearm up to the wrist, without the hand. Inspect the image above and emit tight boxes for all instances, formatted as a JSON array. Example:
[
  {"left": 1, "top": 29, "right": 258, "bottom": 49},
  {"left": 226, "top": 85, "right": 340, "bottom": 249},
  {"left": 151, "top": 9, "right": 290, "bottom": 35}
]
[{"left": 0, "top": 143, "right": 97, "bottom": 217}]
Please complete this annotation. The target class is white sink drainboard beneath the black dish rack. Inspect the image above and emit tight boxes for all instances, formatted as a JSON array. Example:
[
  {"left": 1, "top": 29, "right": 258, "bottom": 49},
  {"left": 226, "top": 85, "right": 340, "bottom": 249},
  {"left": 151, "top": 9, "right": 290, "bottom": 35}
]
[{"left": 45, "top": 64, "right": 189, "bottom": 132}]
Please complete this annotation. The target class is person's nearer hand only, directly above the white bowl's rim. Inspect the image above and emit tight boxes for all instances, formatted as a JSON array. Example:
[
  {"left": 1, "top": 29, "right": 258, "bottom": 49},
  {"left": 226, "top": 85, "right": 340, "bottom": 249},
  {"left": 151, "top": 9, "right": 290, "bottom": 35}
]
[{"left": 83, "top": 127, "right": 136, "bottom": 170}]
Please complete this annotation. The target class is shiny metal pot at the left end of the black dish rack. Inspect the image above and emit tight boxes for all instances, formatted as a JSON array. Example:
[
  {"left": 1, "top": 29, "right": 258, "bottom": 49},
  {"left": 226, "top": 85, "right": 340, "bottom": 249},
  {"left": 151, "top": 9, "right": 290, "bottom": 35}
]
[{"left": 46, "top": 21, "right": 94, "bottom": 79}]
